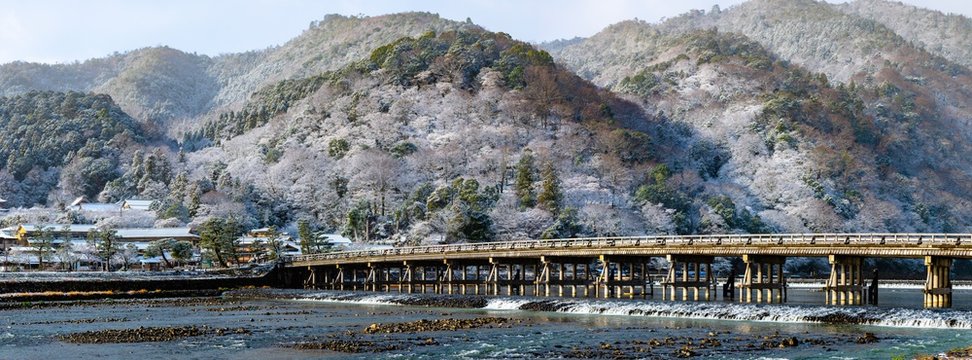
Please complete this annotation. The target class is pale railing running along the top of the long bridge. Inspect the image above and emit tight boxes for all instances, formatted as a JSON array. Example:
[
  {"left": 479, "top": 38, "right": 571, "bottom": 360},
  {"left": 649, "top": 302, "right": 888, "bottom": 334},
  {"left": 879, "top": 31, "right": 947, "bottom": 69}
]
[{"left": 289, "top": 233, "right": 972, "bottom": 262}]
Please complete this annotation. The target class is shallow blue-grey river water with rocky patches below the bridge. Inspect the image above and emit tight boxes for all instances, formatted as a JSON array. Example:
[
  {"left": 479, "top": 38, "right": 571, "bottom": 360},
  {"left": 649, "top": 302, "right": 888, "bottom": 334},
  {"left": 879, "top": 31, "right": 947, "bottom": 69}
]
[{"left": 0, "top": 288, "right": 972, "bottom": 360}]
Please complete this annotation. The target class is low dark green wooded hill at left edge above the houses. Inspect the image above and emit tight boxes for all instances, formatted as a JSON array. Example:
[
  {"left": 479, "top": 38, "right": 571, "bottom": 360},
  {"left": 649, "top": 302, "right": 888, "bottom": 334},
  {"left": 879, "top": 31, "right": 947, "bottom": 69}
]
[{"left": 0, "top": 92, "right": 143, "bottom": 206}]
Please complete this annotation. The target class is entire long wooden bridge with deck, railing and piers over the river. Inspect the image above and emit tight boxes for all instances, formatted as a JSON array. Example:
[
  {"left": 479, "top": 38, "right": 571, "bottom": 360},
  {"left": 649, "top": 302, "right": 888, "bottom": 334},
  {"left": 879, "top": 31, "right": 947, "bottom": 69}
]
[{"left": 286, "top": 234, "right": 972, "bottom": 308}]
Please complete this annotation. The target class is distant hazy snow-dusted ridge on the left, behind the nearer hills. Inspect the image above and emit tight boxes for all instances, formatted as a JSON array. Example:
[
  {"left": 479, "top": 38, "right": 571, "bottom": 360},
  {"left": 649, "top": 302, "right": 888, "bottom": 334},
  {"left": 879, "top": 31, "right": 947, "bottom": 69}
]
[{"left": 0, "top": 13, "right": 475, "bottom": 133}]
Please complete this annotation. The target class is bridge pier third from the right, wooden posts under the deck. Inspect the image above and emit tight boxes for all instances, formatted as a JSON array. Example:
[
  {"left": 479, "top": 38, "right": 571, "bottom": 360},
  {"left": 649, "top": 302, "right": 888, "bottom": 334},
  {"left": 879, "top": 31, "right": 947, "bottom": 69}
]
[{"left": 739, "top": 255, "right": 786, "bottom": 303}]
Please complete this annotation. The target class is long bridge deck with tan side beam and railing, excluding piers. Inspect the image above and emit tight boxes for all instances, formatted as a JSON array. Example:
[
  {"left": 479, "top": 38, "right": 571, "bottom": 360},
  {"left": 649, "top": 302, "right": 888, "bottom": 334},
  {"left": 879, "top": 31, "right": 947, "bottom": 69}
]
[{"left": 287, "top": 233, "right": 972, "bottom": 267}]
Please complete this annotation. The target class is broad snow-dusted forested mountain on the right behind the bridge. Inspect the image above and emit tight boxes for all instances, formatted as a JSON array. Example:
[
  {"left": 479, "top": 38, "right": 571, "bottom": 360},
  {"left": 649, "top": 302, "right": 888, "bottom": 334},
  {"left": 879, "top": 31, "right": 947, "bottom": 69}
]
[{"left": 551, "top": 0, "right": 972, "bottom": 235}]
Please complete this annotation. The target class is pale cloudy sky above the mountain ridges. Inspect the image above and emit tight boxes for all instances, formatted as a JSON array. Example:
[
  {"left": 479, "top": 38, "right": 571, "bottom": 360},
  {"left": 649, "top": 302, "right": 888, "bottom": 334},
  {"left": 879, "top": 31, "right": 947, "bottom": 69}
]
[{"left": 0, "top": 0, "right": 972, "bottom": 63}]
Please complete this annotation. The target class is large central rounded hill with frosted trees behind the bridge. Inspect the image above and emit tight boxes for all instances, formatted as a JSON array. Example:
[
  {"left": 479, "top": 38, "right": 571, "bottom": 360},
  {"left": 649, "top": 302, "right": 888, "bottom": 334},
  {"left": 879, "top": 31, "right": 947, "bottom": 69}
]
[{"left": 175, "top": 29, "right": 685, "bottom": 242}]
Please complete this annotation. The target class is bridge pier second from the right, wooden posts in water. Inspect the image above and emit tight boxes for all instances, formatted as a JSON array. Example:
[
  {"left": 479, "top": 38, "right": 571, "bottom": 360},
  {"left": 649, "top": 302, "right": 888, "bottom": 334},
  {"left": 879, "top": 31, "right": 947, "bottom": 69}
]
[{"left": 824, "top": 255, "right": 864, "bottom": 305}]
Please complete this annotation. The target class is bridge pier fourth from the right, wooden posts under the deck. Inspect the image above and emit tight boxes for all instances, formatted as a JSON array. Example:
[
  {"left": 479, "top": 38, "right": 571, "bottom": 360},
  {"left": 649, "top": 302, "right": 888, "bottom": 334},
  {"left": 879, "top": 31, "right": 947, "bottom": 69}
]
[{"left": 661, "top": 255, "right": 715, "bottom": 301}]
